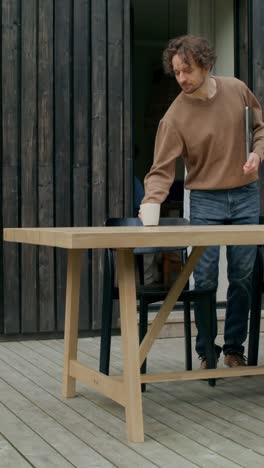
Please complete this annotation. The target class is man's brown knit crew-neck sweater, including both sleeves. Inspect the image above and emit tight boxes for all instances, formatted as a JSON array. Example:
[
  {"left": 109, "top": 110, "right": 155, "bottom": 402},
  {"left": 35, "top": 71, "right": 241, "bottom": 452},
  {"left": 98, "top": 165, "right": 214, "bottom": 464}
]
[{"left": 143, "top": 76, "right": 264, "bottom": 203}]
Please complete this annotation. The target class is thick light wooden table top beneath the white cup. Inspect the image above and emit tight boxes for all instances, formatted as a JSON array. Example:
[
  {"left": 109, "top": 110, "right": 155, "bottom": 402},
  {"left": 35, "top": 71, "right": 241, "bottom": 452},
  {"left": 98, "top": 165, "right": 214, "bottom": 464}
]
[{"left": 4, "top": 225, "right": 264, "bottom": 249}]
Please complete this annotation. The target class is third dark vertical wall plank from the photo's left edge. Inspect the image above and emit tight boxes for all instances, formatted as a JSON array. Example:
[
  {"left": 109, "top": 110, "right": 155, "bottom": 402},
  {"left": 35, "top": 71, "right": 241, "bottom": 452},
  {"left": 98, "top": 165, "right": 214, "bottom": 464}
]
[{"left": 38, "top": 0, "right": 55, "bottom": 331}]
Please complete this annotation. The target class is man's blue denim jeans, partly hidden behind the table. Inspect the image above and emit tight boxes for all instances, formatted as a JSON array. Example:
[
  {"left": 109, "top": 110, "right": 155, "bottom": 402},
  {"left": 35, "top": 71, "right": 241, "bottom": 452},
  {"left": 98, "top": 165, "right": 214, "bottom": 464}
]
[{"left": 190, "top": 182, "right": 259, "bottom": 356}]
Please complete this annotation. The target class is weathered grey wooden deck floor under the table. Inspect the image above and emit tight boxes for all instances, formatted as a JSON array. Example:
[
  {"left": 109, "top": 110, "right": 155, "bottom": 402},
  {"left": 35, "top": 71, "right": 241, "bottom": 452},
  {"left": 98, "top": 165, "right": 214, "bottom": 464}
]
[{"left": 0, "top": 337, "right": 264, "bottom": 468}]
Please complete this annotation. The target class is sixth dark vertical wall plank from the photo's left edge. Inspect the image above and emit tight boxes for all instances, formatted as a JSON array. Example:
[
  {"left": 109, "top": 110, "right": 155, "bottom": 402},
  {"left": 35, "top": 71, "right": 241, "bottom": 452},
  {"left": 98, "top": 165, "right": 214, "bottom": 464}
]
[{"left": 91, "top": 0, "right": 108, "bottom": 328}]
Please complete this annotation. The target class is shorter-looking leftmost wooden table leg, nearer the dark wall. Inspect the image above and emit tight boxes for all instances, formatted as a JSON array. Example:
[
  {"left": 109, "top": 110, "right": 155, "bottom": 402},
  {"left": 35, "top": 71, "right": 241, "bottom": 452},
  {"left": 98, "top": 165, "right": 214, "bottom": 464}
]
[{"left": 62, "top": 250, "right": 81, "bottom": 398}]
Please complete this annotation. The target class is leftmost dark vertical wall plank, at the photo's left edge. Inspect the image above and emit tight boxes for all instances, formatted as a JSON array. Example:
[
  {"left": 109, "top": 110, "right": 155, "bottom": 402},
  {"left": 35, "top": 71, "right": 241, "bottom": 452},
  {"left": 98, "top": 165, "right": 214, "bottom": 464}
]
[{"left": 1, "top": 0, "right": 20, "bottom": 333}]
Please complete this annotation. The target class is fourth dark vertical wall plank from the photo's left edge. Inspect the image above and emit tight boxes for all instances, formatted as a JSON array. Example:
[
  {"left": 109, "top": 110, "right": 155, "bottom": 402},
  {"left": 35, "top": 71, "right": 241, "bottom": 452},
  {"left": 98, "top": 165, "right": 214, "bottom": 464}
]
[{"left": 54, "top": 0, "right": 72, "bottom": 330}]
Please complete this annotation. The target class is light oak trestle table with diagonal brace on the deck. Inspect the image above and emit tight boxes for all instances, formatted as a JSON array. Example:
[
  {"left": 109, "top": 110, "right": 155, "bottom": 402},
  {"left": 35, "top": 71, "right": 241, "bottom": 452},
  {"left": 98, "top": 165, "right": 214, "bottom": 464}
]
[{"left": 4, "top": 225, "right": 264, "bottom": 442}]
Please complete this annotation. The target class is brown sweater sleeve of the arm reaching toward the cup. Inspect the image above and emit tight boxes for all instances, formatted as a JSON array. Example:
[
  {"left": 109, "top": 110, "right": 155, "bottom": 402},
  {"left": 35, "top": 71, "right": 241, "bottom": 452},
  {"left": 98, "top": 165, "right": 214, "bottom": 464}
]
[{"left": 142, "top": 120, "right": 184, "bottom": 203}]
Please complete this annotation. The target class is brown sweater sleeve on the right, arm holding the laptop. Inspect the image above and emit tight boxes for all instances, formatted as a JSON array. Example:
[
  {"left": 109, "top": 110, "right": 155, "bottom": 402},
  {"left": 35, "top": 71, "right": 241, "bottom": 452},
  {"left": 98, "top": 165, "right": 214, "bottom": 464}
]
[{"left": 244, "top": 88, "right": 264, "bottom": 160}]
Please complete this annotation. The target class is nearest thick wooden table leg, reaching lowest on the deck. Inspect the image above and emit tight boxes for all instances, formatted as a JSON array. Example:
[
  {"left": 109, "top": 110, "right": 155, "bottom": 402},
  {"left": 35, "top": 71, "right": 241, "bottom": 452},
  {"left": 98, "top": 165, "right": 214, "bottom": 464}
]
[{"left": 117, "top": 250, "right": 144, "bottom": 442}]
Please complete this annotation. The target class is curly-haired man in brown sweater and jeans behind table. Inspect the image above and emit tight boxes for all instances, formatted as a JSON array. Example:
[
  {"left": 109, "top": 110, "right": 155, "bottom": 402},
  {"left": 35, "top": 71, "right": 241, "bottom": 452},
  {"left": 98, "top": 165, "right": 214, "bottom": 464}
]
[{"left": 142, "top": 35, "right": 264, "bottom": 368}]
